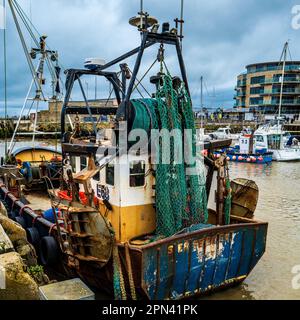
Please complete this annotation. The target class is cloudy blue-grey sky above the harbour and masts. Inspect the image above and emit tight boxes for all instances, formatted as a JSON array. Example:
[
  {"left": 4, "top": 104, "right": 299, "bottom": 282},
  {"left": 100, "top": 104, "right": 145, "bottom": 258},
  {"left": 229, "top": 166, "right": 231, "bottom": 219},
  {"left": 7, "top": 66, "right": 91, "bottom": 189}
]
[{"left": 0, "top": 0, "right": 300, "bottom": 114}]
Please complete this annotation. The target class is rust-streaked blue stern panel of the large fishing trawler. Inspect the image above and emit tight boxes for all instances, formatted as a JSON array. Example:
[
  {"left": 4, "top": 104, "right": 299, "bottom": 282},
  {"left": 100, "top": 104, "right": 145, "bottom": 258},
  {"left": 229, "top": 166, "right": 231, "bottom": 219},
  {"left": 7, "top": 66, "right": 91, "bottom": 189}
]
[{"left": 135, "top": 218, "right": 267, "bottom": 300}]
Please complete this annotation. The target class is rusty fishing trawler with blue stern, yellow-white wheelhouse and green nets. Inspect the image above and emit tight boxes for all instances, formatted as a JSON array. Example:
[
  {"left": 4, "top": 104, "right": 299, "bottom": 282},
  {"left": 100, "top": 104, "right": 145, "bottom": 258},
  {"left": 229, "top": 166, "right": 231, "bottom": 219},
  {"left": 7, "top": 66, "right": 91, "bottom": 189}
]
[{"left": 0, "top": 8, "right": 268, "bottom": 300}]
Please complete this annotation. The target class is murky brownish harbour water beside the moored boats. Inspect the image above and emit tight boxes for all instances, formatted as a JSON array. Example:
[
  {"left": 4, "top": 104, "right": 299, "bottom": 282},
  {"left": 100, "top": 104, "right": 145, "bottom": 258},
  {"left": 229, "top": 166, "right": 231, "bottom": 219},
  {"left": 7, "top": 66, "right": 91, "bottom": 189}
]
[{"left": 0, "top": 141, "right": 300, "bottom": 300}]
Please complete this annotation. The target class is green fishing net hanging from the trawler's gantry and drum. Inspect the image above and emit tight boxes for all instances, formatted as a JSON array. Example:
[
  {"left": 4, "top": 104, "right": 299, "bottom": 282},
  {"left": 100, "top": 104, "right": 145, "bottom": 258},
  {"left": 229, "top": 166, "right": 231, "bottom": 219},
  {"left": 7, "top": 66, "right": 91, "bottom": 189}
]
[{"left": 131, "top": 74, "right": 208, "bottom": 237}]
